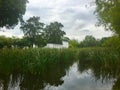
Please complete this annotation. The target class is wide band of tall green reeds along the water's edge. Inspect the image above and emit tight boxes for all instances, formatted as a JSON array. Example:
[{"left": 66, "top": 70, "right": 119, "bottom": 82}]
[{"left": 0, "top": 48, "right": 120, "bottom": 74}]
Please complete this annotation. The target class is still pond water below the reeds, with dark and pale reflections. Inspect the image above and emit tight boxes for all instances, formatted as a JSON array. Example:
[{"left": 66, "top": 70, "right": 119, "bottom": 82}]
[{"left": 0, "top": 59, "right": 120, "bottom": 90}]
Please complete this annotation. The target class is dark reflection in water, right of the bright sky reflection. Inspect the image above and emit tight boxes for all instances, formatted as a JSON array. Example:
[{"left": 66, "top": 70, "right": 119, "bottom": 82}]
[{"left": 78, "top": 50, "right": 120, "bottom": 90}]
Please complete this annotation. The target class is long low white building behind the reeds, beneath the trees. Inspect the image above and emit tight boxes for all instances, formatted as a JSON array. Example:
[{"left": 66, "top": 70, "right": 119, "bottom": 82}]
[{"left": 45, "top": 41, "right": 69, "bottom": 48}]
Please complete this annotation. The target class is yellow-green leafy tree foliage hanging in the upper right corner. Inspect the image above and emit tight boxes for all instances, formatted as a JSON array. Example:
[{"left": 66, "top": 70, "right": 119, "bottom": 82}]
[{"left": 95, "top": 0, "right": 120, "bottom": 35}]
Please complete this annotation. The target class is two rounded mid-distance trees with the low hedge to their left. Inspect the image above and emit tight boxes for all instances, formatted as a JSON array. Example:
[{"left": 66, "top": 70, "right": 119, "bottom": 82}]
[{"left": 0, "top": 16, "right": 66, "bottom": 48}]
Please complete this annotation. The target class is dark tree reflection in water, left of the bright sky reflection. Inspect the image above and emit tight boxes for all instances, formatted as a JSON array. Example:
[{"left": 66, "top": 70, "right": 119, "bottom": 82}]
[{"left": 0, "top": 60, "right": 73, "bottom": 90}]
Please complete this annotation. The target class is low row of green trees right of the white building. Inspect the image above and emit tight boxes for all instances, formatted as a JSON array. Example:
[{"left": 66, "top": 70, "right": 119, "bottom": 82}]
[{"left": 69, "top": 35, "right": 120, "bottom": 49}]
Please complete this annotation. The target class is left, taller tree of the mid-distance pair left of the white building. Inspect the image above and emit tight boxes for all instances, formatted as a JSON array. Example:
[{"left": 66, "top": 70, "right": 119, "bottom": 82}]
[{"left": 20, "top": 16, "right": 44, "bottom": 46}]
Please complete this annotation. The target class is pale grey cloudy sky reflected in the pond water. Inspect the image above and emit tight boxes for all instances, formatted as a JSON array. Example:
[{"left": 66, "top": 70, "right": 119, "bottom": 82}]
[{"left": 45, "top": 63, "right": 112, "bottom": 90}]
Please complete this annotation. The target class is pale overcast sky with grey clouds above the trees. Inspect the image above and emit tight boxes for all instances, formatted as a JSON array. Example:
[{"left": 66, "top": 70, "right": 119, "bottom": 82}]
[{"left": 0, "top": 0, "right": 112, "bottom": 41}]
